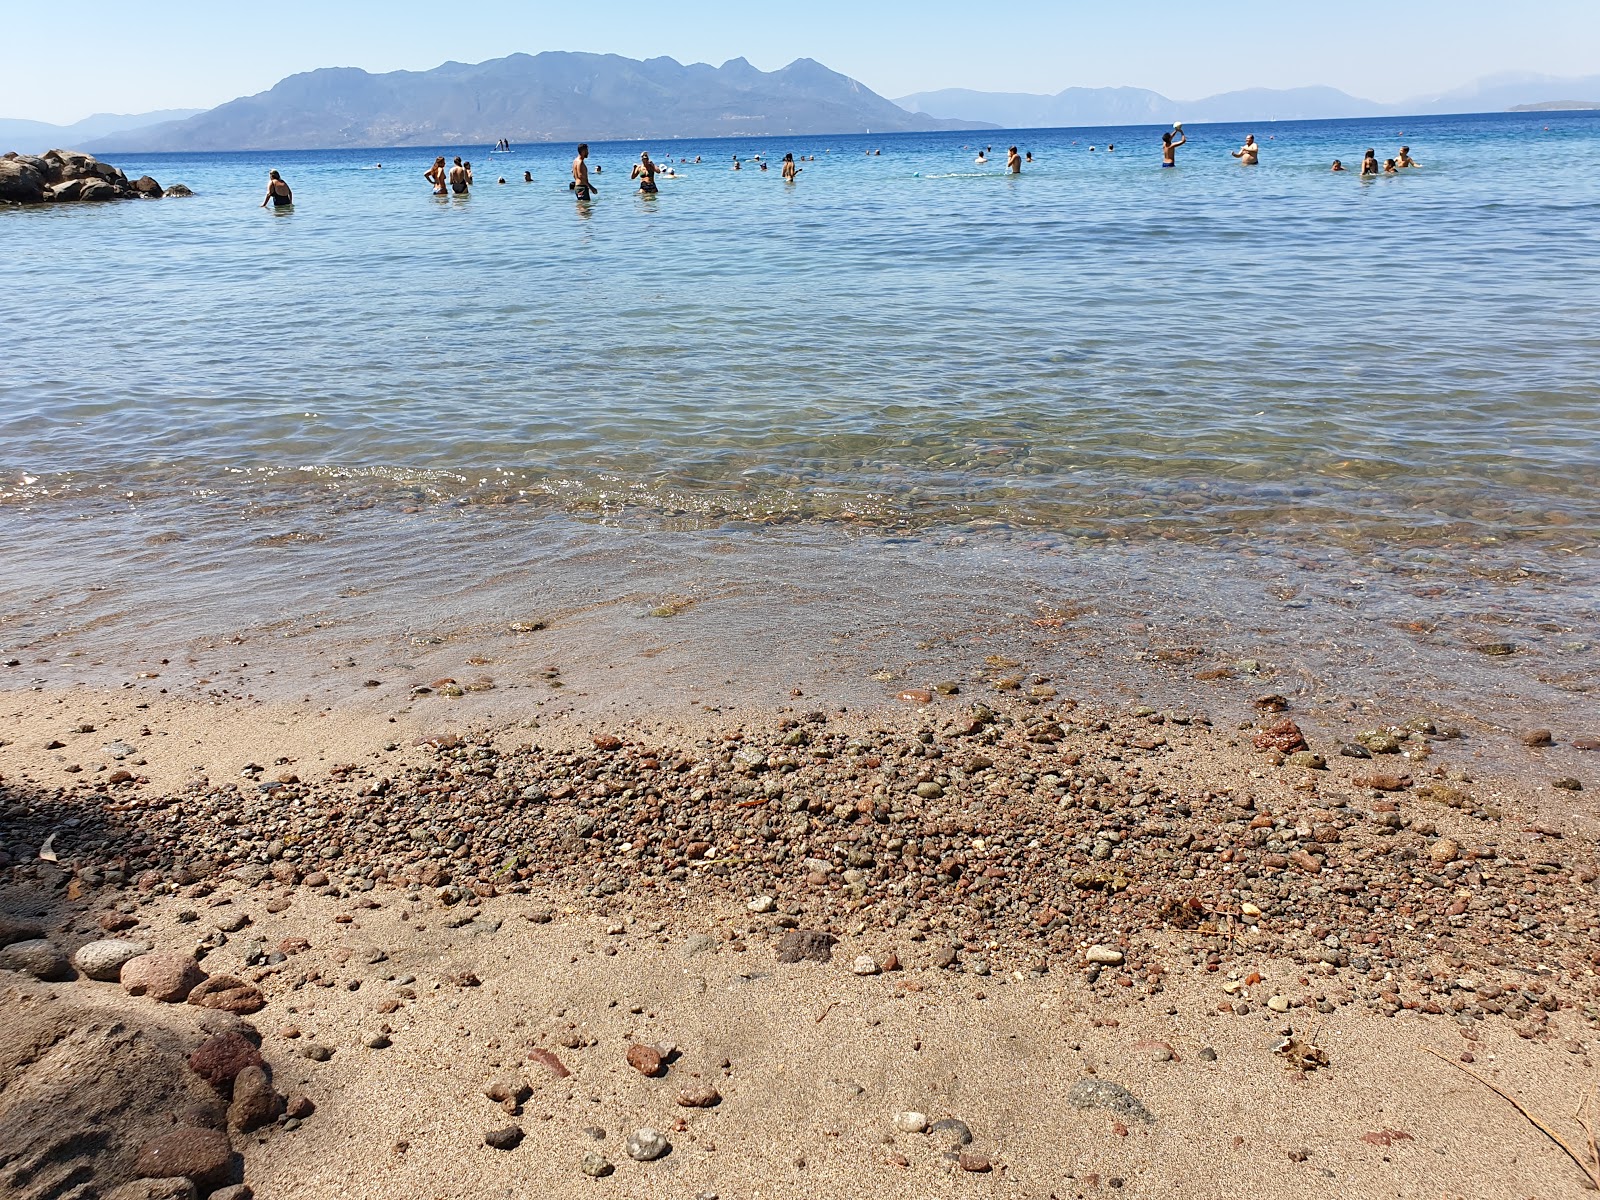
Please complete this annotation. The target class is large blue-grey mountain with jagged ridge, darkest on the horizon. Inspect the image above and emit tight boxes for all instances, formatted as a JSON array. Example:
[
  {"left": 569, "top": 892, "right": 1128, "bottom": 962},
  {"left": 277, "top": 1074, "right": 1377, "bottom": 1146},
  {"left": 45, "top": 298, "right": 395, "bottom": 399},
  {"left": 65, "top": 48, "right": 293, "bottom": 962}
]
[{"left": 91, "top": 51, "right": 976, "bottom": 150}]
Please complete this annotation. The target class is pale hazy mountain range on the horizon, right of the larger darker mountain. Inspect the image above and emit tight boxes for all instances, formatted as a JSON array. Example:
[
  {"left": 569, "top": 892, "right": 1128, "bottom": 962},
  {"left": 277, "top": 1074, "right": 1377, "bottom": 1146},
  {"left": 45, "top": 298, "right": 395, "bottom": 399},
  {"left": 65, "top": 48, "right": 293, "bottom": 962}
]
[{"left": 894, "top": 74, "right": 1600, "bottom": 130}]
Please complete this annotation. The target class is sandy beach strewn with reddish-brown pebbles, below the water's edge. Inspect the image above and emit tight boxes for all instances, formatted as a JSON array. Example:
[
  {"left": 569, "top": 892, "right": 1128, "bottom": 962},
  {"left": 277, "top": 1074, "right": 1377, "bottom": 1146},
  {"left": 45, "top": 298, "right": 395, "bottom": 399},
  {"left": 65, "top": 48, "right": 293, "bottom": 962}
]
[{"left": 0, "top": 643, "right": 1600, "bottom": 1200}]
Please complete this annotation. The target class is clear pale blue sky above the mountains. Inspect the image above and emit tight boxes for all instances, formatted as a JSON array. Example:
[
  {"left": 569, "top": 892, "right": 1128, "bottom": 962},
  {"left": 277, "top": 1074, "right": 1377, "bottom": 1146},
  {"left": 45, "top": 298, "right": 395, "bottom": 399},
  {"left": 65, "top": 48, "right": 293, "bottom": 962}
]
[{"left": 0, "top": 0, "right": 1600, "bottom": 123}]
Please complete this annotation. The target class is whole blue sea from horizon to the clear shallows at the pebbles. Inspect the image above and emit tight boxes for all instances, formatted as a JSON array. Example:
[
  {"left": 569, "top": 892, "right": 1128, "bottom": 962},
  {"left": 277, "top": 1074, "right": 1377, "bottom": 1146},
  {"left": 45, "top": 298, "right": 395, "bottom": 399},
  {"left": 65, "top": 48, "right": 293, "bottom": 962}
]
[{"left": 0, "top": 112, "right": 1600, "bottom": 752}]
